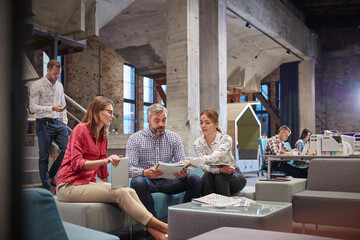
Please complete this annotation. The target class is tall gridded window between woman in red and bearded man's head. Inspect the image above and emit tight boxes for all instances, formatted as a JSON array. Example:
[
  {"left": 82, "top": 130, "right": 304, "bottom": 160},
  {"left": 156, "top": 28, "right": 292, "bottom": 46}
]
[{"left": 123, "top": 64, "right": 136, "bottom": 134}]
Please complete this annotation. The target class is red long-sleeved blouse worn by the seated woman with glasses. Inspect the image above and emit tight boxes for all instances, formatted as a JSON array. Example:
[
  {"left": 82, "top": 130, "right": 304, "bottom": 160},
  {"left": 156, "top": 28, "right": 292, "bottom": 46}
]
[{"left": 56, "top": 123, "right": 109, "bottom": 185}]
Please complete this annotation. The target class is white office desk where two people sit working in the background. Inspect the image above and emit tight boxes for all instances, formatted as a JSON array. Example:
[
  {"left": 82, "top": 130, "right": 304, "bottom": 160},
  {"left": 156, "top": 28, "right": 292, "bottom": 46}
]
[{"left": 260, "top": 155, "right": 360, "bottom": 179}]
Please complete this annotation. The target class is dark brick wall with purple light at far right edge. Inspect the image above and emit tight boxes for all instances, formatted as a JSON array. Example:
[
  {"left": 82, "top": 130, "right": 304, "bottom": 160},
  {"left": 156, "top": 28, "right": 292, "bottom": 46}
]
[{"left": 315, "top": 45, "right": 360, "bottom": 133}]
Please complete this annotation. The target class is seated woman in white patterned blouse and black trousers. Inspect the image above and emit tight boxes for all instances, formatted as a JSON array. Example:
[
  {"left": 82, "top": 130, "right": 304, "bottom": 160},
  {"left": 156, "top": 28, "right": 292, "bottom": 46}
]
[{"left": 194, "top": 109, "right": 246, "bottom": 196}]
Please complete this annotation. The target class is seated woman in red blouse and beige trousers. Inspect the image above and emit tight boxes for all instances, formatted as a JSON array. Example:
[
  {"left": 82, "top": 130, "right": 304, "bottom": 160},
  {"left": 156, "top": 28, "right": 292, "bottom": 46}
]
[{"left": 56, "top": 96, "right": 168, "bottom": 239}]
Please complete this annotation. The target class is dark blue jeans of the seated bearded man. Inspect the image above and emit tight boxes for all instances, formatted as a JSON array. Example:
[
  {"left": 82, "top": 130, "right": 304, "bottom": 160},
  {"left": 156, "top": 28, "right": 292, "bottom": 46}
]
[{"left": 130, "top": 174, "right": 201, "bottom": 216}]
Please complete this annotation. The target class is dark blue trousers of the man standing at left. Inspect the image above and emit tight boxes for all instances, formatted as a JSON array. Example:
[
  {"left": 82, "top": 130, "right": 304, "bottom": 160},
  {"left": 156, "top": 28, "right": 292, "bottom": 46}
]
[{"left": 36, "top": 118, "right": 69, "bottom": 190}]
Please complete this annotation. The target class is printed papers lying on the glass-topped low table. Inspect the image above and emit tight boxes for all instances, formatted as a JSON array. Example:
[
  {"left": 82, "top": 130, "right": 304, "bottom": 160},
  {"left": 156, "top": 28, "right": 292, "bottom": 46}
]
[{"left": 192, "top": 193, "right": 250, "bottom": 208}]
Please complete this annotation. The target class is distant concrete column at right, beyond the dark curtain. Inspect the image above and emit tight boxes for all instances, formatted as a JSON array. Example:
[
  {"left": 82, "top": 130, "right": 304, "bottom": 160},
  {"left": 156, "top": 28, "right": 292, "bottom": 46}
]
[{"left": 299, "top": 60, "right": 315, "bottom": 134}]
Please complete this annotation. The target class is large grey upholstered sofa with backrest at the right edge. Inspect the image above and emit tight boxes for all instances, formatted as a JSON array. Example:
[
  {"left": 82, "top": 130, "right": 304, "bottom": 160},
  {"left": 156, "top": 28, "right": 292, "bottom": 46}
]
[{"left": 292, "top": 158, "right": 360, "bottom": 228}]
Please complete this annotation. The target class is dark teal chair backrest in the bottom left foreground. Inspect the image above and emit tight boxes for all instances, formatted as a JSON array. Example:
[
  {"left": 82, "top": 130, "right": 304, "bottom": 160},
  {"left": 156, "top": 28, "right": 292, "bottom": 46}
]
[{"left": 22, "top": 188, "right": 68, "bottom": 240}]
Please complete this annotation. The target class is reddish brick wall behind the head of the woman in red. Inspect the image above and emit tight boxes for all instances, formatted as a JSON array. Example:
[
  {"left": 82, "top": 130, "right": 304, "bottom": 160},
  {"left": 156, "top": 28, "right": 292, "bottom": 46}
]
[{"left": 64, "top": 38, "right": 124, "bottom": 133}]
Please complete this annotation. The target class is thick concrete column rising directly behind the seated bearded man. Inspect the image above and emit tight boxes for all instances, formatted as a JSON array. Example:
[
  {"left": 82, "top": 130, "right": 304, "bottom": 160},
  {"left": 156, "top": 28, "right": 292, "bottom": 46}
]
[{"left": 166, "top": 0, "right": 200, "bottom": 156}]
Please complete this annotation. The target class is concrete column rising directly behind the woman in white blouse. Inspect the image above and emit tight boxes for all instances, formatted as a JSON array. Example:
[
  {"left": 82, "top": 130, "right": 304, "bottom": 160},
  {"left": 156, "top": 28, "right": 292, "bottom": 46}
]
[{"left": 199, "top": 0, "right": 227, "bottom": 132}]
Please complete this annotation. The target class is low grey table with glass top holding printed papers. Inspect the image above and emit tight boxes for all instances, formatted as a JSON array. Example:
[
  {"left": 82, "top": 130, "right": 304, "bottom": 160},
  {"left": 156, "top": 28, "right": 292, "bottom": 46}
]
[{"left": 168, "top": 201, "right": 292, "bottom": 240}]
